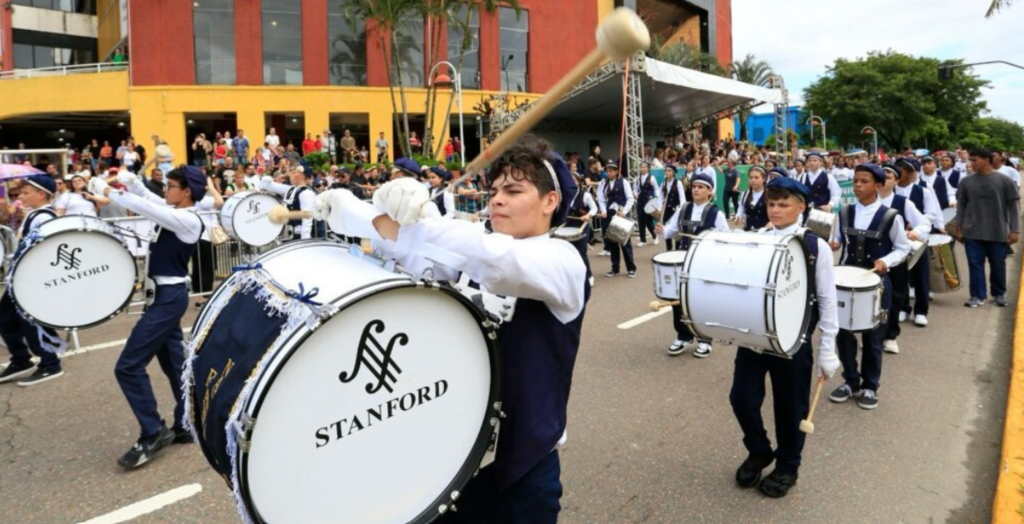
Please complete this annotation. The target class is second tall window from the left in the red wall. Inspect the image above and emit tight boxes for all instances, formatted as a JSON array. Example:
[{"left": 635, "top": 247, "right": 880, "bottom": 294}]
[{"left": 263, "top": 0, "right": 302, "bottom": 86}]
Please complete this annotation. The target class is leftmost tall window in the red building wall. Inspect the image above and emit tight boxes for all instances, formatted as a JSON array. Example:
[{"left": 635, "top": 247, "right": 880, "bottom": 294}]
[{"left": 193, "top": 0, "right": 234, "bottom": 85}]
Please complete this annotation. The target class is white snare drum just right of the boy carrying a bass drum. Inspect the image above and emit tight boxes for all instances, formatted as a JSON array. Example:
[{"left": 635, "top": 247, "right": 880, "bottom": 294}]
[{"left": 836, "top": 266, "right": 884, "bottom": 332}]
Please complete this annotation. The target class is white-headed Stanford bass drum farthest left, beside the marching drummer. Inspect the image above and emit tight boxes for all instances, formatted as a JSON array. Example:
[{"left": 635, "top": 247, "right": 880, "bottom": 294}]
[{"left": 7, "top": 216, "right": 138, "bottom": 330}]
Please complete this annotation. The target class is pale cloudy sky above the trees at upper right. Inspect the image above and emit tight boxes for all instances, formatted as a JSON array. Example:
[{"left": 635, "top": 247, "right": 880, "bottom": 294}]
[{"left": 732, "top": 0, "right": 1024, "bottom": 125}]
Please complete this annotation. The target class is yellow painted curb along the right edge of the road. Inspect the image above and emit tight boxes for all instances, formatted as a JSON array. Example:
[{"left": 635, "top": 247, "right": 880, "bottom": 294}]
[{"left": 992, "top": 255, "right": 1024, "bottom": 524}]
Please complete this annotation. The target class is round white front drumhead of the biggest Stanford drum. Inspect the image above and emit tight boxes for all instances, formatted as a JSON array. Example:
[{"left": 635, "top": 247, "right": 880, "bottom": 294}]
[{"left": 244, "top": 286, "right": 492, "bottom": 524}]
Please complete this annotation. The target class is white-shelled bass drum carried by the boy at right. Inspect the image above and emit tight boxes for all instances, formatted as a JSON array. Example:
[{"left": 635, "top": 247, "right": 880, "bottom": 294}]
[{"left": 681, "top": 231, "right": 813, "bottom": 357}]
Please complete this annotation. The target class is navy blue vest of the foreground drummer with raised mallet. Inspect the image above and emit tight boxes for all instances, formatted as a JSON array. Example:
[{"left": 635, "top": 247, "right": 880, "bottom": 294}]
[{"left": 492, "top": 280, "right": 590, "bottom": 489}]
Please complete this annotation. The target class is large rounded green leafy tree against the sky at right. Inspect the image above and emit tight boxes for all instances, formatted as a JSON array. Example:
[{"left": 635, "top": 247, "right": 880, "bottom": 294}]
[{"left": 804, "top": 50, "right": 988, "bottom": 148}]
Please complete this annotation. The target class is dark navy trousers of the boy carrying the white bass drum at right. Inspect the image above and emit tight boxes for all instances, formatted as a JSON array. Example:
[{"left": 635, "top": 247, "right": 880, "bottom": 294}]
[{"left": 729, "top": 342, "right": 814, "bottom": 473}]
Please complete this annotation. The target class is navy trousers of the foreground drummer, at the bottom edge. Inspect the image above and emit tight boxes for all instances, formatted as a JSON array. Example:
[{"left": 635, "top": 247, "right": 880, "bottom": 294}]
[{"left": 434, "top": 451, "right": 562, "bottom": 524}]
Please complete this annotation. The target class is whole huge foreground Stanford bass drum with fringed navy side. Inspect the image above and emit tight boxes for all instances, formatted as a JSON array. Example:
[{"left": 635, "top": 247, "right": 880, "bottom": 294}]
[{"left": 184, "top": 241, "right": 501, "bottom": 524}]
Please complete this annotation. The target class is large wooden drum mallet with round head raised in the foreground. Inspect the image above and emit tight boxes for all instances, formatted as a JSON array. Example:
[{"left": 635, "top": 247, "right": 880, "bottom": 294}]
[{"left": 453, "top": 7, "right": 650, "bottom": 185}]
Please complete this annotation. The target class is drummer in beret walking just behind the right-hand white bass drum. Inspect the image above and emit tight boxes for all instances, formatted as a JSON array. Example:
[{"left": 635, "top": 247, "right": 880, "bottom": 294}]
[{"left": 656, "top": 173, "right": 729, "bottom": 358}]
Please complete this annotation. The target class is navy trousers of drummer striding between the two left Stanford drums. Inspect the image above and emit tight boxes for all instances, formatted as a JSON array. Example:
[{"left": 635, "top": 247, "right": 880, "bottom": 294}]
[{"left": 114, "top": 283, "right": 188, "bottom": 437}]
